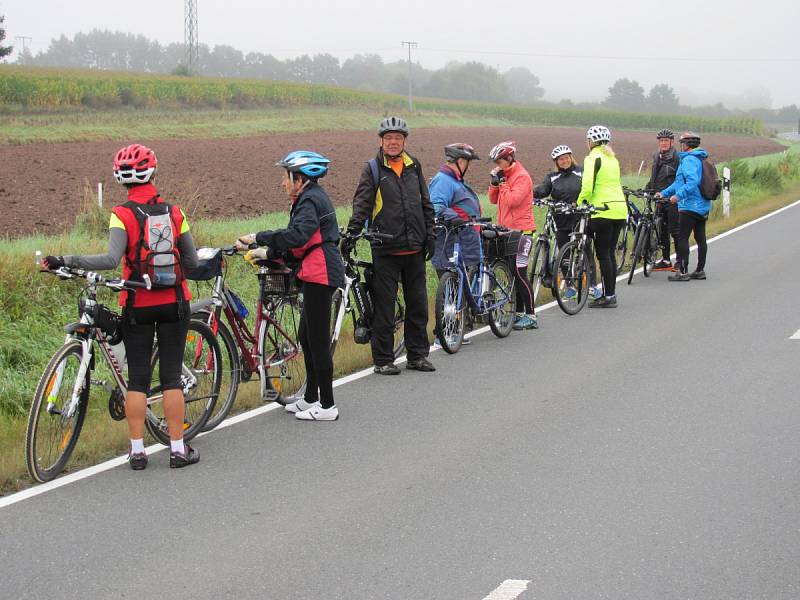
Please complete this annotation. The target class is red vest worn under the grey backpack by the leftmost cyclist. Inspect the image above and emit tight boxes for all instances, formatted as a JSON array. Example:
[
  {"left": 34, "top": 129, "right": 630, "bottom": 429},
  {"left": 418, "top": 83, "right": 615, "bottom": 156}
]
[{"left": 111, "top": 183, "right": 192, "bottom": 308}]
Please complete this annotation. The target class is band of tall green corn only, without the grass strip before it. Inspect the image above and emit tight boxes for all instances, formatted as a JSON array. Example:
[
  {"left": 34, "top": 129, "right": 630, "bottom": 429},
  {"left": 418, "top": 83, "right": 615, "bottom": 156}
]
[{"left": 0, "top": 65, "right": 764, "bottom": 135}]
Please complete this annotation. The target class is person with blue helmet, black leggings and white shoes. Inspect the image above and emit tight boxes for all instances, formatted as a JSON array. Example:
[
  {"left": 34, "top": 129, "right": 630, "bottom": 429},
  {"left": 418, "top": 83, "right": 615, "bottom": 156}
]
[{"left": 238, "top": 150, "right": 344, "bottom": 421}]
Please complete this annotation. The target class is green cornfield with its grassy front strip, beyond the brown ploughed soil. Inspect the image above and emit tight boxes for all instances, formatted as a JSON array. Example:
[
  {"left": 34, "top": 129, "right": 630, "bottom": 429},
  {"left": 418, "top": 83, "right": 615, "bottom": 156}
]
[{"left": 0, "top": 65, "right": 764, "bottom": 144}]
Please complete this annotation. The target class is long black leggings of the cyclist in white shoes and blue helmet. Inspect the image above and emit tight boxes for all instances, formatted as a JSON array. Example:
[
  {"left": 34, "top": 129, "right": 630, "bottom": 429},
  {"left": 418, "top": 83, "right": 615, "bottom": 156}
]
[{"left": 297, "top": 281, "right": 334, "bottom": 408}]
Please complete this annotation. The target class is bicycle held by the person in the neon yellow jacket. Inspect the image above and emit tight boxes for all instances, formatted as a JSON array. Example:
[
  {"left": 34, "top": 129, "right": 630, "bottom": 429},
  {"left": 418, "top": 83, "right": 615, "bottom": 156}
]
[{"left": 552, "top": 204, "right": 604, "bottom": 315}]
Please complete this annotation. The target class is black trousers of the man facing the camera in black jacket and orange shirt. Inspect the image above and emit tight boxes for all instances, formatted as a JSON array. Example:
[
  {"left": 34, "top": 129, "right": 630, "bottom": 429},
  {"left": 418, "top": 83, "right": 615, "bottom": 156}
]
[{"left": 372, "top": 252, "right": 429, "bottom": 367}]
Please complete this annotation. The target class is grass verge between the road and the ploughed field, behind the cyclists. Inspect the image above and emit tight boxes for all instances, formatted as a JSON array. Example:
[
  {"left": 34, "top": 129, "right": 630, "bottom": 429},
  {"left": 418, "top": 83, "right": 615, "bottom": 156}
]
[{"left": 0, "top": 145, "right": 800, "bottom": 493}]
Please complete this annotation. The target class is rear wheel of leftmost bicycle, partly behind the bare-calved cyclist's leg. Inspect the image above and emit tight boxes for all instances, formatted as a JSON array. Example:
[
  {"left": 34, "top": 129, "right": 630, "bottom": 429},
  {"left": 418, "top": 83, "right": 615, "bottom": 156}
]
[{"left": 144, "top": 320, "right": 222, "bottom": 446}]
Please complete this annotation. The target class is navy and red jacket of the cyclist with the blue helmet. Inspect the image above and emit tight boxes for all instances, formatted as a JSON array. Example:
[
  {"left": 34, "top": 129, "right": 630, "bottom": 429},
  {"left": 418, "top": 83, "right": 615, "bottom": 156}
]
[{"left": 256, "top": 181, "right": 344, "bottom": 287}]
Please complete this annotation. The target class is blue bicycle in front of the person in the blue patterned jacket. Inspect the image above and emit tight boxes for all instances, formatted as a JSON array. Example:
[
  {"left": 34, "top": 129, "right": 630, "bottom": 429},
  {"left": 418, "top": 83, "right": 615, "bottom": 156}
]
[{"left": 436, "top": 219, "right": 519, "bottom": 354}]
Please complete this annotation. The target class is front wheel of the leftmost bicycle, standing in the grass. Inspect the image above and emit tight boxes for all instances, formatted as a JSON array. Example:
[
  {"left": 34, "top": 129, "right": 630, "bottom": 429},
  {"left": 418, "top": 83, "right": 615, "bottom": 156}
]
[{"left": 25, "top": 340, "right": 89, "bottom": 482}]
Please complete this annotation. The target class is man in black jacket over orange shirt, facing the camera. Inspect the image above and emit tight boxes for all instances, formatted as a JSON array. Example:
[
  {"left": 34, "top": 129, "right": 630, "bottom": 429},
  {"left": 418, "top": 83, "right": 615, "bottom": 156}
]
[{"left": 342, "top": 117, "right": 436, "bottom": 375}]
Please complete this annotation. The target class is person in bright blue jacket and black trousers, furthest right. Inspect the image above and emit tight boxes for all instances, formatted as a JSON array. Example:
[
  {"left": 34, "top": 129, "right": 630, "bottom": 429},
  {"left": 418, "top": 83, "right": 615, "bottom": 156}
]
[{"left": 656, "top": 131, "right": 711, "bottom": 281}]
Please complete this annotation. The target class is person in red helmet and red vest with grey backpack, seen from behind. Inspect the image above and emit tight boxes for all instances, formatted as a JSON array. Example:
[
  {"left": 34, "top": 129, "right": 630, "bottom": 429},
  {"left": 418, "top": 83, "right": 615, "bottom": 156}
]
[{"left": 44, "top": 144, "right": 200, "bottom": 471}]
